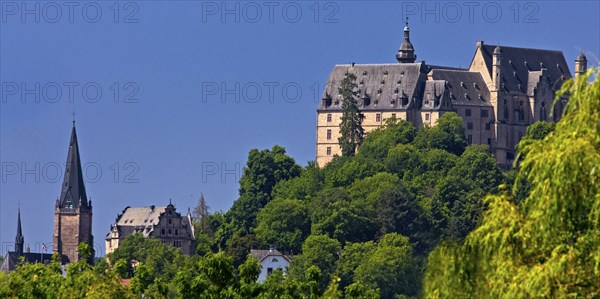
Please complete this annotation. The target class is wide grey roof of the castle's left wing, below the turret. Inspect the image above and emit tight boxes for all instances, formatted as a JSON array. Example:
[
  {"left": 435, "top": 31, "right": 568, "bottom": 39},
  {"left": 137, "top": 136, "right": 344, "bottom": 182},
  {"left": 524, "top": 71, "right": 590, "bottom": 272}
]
[{"left": 319, "top": 62, "right": 427, "bottom": 111}]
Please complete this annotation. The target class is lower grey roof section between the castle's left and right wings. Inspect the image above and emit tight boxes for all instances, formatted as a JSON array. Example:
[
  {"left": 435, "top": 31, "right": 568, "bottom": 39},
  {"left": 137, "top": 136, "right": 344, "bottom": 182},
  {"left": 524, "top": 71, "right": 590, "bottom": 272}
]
[{"left": 429, "top": 69, "right": 492, "bottom": 106}]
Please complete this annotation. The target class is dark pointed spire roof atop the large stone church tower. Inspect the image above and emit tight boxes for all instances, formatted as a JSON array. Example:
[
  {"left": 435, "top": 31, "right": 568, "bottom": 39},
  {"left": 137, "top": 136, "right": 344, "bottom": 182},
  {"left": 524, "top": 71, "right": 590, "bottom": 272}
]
[{"left": 58, "top": 122, "right": 89, "bottom": 209}]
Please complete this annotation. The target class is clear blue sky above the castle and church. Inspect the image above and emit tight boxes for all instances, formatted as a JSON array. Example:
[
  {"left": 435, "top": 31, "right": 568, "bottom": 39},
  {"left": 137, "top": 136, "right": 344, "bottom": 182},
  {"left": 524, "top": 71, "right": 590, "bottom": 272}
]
[{"left": 0, "top": 0, "right": 600, "bottom": 254}]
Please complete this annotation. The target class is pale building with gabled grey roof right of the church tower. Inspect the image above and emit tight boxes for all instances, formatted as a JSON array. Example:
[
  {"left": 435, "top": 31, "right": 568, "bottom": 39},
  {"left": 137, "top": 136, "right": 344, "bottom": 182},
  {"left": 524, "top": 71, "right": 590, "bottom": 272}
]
[{"left": 106, "top": 203, "right": 196, "bottom": 255}]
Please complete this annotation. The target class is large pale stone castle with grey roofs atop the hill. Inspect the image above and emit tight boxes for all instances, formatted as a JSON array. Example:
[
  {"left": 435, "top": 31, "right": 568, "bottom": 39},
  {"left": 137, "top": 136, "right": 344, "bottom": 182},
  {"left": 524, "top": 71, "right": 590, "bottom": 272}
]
[{"left": 316, "top": 19, "right": 587, "bottom": 167}]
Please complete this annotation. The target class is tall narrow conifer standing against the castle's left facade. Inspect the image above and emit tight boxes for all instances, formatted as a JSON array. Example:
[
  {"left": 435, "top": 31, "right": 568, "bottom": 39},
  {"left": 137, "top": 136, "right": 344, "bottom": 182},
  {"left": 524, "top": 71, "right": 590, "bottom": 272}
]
[{"left": 338, "top": 73, "right": 364, "bottom": 157}]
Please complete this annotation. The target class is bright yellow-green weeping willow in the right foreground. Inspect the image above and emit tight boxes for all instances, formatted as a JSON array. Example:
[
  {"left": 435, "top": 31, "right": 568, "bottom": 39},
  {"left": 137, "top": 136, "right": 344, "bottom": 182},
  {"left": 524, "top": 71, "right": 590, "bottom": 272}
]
[{"left": 424, "top": 69, "right": 600, "bottom": 298}]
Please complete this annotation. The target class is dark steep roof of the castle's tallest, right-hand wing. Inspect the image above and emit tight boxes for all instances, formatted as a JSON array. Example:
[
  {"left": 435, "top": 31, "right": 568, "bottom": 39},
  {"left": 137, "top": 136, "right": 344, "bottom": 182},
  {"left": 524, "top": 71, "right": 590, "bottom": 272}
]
[{"left": 482, "top": 45, "right": 571, "bottom": 93}]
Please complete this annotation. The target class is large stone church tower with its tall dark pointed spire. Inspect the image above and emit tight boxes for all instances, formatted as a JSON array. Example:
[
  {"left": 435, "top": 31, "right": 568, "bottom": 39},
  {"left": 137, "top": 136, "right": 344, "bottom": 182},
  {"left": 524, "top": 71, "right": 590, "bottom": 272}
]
[{"left": 53, "top": 122, "right": 95, "bottom": 264}]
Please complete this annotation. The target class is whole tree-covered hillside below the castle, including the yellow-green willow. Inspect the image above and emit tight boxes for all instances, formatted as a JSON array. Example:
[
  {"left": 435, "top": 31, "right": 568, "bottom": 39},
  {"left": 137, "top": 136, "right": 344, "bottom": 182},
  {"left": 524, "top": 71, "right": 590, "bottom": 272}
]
[{"left": 0, "top": 70, "right": 600, "bottom": 298}]
